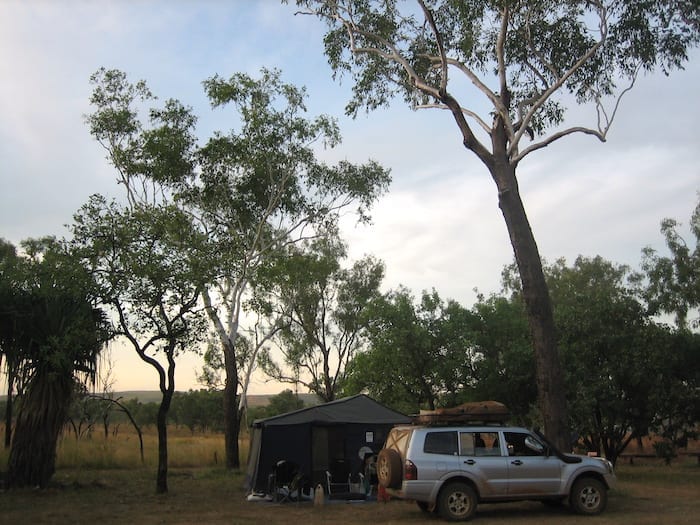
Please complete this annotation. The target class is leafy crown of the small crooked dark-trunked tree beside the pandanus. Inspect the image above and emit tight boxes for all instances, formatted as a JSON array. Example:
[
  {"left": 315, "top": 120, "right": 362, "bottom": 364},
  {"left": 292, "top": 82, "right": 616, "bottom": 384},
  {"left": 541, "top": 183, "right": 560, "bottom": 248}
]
[{"left": 72, "top": 195, "right": 213, "bottom": 358}]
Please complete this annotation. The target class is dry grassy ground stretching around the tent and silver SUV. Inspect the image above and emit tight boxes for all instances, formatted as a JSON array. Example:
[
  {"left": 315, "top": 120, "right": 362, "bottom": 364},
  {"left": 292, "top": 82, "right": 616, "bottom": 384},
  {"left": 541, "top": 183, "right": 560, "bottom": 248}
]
[{"left": 0, "top": 426, "right": 700, "bottom": 525}]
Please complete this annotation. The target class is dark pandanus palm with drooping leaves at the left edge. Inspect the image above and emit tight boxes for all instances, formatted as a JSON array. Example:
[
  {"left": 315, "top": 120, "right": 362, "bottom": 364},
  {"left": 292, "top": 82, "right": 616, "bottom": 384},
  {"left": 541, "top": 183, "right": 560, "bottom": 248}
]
[{"left": 0, "top": 238, "right": 110, "bottom": 488}]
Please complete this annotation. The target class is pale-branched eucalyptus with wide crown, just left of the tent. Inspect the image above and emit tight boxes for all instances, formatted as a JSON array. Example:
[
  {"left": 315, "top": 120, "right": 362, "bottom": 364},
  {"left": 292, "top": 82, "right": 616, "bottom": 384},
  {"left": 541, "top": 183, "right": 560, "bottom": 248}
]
[{"left": 83, "top": 66, "right": 390, "bottom": 467}]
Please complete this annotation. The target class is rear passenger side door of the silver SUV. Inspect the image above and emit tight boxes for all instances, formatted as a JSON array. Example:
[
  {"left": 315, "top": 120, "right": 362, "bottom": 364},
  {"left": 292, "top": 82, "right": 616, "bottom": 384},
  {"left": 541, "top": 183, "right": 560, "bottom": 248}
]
[{"left": 459, "top": 430, "right": 508, "bottom": 498}]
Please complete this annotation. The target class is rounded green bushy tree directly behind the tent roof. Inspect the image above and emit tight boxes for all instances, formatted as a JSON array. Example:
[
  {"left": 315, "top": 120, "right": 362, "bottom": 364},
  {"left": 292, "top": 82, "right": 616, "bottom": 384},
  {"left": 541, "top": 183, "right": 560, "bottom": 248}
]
[{"left": 344, "top": 288, "right": 475, "bottom": 413}]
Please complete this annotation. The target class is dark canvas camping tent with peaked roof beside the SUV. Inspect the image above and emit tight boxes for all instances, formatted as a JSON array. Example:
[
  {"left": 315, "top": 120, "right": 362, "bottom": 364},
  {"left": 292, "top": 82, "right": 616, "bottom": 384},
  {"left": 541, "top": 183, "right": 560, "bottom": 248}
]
[{"left": 246, "top": 394, "right": 411, "bottom": 492}]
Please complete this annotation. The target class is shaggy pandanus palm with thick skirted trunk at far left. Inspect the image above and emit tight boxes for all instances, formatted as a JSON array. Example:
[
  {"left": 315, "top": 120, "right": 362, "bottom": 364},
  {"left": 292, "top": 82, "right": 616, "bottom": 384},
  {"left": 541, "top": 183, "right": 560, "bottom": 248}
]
[{"left": 7, "top": 239, "right": 108, "bottom": 487}]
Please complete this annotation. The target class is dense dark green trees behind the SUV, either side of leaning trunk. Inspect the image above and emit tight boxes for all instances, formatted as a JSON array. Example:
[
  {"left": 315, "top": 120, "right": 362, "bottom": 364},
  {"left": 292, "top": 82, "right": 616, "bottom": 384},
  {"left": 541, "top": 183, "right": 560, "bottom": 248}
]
[{"left": 345, "top": 203, "right": 700, "bottom": 461}]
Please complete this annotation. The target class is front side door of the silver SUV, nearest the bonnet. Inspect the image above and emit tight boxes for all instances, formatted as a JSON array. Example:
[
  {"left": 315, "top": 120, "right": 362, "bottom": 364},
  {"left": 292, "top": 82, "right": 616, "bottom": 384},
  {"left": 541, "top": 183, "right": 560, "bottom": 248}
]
[{"left": 503, "top": 432, "right": 562, "bottom": 496}]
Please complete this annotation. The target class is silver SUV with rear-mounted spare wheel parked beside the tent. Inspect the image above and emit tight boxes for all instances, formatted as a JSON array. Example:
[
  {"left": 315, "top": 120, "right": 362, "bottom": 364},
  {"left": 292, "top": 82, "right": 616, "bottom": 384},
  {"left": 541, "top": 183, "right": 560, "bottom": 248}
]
[{"left": 377, "top": 425, "right": 615, "bottom": 521}]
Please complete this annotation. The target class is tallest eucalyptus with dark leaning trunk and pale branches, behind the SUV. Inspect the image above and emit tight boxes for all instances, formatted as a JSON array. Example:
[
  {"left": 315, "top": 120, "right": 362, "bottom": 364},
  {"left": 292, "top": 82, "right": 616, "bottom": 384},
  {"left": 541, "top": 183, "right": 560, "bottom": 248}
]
[{"left": 296, "top": 0, "right": 700, "bottom": 445}]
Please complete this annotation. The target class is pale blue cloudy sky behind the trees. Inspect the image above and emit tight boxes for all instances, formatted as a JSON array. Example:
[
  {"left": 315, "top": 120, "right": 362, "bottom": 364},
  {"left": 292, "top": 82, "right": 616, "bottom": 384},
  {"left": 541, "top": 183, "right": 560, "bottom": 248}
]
[{"left": 0, "top": 0, "right": 700, "bottom": 392}]
